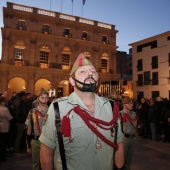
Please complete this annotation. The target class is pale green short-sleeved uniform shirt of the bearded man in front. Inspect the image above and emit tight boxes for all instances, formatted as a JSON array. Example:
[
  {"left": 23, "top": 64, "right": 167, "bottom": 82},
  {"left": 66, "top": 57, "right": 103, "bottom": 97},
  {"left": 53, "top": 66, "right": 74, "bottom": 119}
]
[{"left": 39, "top": 92, "right": 123, "bottom": 170}]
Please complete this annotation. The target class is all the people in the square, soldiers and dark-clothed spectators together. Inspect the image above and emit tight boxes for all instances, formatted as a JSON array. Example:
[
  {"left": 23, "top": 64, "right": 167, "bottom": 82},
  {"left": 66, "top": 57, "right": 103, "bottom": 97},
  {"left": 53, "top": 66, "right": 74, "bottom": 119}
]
[{"left": 0, "top": 53, "right": 170, "bottom": 170}]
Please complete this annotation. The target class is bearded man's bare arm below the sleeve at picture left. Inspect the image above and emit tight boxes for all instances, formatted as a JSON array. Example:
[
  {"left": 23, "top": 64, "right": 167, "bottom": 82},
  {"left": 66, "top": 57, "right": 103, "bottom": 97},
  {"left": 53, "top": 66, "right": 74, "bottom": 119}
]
[{"left": 40, "top": 143, "right": 54, "bottom": 170}]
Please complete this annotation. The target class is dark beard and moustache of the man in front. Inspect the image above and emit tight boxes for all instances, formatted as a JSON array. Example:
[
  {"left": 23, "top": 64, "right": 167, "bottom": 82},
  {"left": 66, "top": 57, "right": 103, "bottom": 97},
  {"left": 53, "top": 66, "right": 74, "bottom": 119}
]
[{"left": 72, "top": 77, "right": 97, "bottom": 92}]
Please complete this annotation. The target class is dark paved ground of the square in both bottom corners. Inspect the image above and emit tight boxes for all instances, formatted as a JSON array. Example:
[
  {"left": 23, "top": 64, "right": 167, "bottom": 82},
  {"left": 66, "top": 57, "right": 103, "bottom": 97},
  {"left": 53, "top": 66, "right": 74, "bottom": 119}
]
[{"left": 0, "top": 136, "right": 170, "bottom": 170}]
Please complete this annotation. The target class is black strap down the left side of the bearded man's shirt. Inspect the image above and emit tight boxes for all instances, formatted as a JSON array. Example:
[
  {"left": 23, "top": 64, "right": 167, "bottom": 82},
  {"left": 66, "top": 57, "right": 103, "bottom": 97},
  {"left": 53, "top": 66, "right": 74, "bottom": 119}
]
[{"left": 53, "top": 102, "right": 67, "bottom": 170}]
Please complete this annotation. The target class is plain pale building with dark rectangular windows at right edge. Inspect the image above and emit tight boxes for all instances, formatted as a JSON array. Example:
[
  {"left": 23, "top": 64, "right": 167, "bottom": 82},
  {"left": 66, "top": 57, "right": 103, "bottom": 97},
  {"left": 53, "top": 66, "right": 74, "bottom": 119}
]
[{"left": 130, "top": 31, "right": 170, "bottom": 99}]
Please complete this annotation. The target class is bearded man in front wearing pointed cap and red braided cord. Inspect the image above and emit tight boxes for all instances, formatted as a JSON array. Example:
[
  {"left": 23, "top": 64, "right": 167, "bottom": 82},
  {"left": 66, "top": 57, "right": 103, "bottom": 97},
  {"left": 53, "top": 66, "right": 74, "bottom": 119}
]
[{"left": 39, "top": 53, "right": 124, "bottom": 170}]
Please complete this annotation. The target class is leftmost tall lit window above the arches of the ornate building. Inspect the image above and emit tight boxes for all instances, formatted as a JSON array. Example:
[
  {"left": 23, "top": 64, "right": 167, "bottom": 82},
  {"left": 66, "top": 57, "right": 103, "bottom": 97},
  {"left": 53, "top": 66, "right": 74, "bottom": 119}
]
[{"left": 15, "top": 48, "right": 24, "bottom": 66}]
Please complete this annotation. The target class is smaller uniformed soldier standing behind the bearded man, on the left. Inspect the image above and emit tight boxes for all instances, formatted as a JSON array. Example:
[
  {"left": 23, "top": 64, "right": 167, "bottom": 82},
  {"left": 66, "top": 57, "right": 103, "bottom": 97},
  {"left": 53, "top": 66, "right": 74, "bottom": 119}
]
[{"left": 25, "top": 88, "right": 49, "bottom": 170}]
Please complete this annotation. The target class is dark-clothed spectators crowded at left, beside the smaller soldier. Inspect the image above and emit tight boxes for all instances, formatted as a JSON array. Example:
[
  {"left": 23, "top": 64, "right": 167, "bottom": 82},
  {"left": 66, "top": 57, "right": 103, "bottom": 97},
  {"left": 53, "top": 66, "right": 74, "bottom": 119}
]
[{"left": 0, "top": 89, "right": 53, "bottom": 162}]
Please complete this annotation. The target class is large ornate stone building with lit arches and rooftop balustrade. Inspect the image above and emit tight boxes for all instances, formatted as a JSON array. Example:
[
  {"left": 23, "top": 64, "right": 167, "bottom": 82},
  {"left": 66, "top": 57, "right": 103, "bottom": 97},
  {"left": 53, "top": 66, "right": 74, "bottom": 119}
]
[{"left": 0, "top": 2, "right": 133, "bottom": 96}]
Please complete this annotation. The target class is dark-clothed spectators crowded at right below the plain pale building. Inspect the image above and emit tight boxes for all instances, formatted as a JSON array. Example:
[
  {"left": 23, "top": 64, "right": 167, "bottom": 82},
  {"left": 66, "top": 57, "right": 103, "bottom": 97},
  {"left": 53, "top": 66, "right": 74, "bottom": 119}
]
[{"left": 135, "top": 96, "right": 170, "bottom": 142}]
